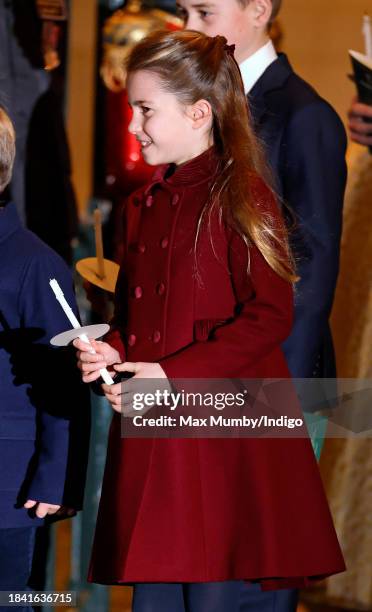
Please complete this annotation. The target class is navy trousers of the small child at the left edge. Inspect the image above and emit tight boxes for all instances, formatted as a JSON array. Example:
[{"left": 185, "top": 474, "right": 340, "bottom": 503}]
[{"left": 0, "top": 527, "right": 36, "bottom": 612}]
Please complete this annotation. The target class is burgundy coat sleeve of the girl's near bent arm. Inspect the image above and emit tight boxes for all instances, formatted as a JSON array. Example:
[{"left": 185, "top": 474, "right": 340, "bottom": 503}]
[{"left": 160, "top": 184, "right": 293, "bottom": 378}]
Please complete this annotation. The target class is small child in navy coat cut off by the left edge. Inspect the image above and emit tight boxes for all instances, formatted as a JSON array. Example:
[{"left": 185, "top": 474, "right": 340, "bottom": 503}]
[{"left": 0, "top": 108, "right": 89, "bottom": 609}]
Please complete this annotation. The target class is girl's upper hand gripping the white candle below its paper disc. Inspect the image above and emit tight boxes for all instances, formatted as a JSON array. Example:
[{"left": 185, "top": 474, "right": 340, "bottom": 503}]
[{"left": 73, "top": 338, "right": 120, "bottom": 383}]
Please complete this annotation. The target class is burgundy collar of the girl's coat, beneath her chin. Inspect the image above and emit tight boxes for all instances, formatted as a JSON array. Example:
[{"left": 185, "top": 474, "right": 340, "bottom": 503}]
[{"left": 146, "top": 146, "right": 219, "bottom": 192}]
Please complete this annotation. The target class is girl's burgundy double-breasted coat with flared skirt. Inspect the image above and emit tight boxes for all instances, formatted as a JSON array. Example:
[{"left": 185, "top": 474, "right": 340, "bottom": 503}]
[{"left": 89, "top": 149, "right": 344, "bottom": 589}]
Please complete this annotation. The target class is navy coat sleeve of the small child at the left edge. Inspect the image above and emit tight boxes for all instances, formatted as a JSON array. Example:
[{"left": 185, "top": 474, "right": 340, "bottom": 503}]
[{"left": 18, "top": 251, "right": 90, "bottom": 509}]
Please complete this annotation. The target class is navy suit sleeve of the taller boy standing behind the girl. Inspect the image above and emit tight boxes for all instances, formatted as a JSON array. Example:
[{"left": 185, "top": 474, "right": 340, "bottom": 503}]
[{"left": 281, "top": 101, "right": 347, "bottom": 378}]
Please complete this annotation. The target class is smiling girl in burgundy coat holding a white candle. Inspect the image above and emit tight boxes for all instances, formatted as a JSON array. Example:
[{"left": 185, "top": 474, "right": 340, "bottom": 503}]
[{"left": 75, "top": 31, "right": 344, "bottom": 612}]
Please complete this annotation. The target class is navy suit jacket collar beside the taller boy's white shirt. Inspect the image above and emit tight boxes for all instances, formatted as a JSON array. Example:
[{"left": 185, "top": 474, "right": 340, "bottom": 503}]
[{"left": 248, "top": 53, "right": 293, "bottom": 124}]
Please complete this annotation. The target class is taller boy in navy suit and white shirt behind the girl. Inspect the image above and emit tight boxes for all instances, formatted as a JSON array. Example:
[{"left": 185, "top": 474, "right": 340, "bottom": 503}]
[{"left": 177, "top": 0, "right": 346, "bottom": 612}]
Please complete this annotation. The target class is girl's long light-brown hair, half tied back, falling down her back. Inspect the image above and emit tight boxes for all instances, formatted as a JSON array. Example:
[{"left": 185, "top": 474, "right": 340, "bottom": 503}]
[{"left": 127, "top": 30, "right": 297, "bottom": 282}]
